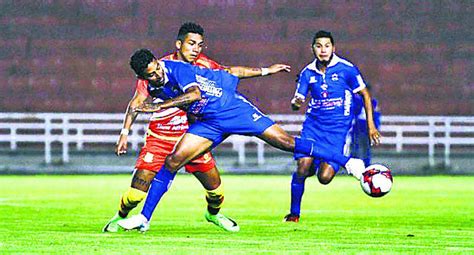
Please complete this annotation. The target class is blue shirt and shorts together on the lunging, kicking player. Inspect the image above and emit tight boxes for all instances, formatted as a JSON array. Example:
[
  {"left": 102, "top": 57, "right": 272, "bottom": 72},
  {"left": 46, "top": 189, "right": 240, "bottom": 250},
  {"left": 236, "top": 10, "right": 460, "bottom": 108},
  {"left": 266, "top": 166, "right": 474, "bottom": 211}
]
[{"left": 148, "top": 58, "right": 275, "bottom": 144}]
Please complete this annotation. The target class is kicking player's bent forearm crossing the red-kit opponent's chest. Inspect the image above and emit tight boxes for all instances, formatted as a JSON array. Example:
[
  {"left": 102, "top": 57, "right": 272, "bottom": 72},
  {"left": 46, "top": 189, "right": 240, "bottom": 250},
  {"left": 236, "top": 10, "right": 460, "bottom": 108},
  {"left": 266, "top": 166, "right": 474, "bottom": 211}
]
[{"left": 134, "top": 85, "right": 201, "bottom": 112}]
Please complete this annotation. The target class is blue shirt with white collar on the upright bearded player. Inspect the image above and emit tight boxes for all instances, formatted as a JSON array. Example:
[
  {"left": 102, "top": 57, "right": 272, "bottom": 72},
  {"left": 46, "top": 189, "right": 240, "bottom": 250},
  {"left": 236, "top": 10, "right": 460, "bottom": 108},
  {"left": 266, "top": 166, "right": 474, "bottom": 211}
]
[{"left": 295, "top": 54, "right": 366, "bottom": 132}]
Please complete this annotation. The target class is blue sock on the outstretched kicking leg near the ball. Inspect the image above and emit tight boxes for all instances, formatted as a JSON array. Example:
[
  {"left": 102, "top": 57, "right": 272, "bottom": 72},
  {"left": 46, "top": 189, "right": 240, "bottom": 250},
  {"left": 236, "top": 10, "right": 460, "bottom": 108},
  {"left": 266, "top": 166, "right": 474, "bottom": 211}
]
[{"left": 295, "top": 137, "right": 349, "bottom": 166}]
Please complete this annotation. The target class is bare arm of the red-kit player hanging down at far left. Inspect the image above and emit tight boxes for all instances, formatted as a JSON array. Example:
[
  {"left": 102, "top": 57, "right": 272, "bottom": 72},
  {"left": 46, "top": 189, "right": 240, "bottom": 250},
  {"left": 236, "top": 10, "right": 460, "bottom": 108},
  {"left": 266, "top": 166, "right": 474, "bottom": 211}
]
[{"left": 115, "top": 91, "right": 147, "bottom": 156}]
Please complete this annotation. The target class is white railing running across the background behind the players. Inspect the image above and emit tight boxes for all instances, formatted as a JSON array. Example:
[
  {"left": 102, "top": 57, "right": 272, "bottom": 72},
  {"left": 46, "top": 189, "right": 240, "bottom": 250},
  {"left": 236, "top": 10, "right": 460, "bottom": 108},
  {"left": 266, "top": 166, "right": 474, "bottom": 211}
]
[{"left": 0, "top": 113, "right": 474, "bottom": 166}]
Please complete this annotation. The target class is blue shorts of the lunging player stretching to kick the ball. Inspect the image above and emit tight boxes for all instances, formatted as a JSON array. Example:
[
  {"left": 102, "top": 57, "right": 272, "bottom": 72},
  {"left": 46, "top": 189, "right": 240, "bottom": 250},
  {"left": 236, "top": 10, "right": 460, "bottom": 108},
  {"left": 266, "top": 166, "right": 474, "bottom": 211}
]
[{"left": 188, "top": 101, "right": 275, "bottom": 148}]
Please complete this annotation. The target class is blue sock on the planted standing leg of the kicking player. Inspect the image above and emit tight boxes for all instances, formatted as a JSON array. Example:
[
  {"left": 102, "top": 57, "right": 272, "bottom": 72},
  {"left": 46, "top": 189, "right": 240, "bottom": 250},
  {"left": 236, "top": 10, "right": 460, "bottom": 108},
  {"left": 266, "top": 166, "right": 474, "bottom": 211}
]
[{"left": 142, "top": 165, "right": 176, "bottom": 221}]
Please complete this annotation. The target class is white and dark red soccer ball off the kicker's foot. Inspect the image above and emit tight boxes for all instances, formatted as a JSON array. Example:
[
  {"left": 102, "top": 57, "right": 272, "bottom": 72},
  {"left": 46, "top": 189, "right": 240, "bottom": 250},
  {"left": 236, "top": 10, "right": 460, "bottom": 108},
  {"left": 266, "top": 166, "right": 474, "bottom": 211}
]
[{"left": 360, "top": 164, "right": 393, "bottom": 197}]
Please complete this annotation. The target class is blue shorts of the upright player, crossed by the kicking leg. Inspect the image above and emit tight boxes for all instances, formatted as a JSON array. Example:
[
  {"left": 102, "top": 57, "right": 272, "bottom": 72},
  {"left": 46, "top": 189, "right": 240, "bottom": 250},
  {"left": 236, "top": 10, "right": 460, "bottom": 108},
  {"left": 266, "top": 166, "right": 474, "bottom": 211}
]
[{"left": 294, "top": 117, "right": 349, "bottom": 173}]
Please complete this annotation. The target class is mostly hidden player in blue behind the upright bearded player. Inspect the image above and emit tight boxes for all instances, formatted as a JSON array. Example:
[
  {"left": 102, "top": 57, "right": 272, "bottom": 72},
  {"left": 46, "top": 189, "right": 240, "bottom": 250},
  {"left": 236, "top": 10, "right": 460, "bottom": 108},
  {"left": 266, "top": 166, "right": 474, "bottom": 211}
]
[{"left": 351, "top": 84, "right": 382, "bottom": 166}]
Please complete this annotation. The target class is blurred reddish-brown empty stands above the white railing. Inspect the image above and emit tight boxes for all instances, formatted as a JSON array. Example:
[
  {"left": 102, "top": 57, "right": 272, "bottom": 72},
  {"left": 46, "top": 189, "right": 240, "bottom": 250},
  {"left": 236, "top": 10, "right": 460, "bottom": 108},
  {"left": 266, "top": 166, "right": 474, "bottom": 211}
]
[{"left": 0, "top": 0, "right": 474, "bottom": 115}]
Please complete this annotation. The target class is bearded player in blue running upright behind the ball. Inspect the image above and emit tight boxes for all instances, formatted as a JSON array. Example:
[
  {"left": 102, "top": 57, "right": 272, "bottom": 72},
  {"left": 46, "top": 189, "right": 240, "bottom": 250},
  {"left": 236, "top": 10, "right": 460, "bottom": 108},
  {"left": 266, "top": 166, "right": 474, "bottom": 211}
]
[{"left": 283, "top": 31, "right": 380, "bottom": 222}]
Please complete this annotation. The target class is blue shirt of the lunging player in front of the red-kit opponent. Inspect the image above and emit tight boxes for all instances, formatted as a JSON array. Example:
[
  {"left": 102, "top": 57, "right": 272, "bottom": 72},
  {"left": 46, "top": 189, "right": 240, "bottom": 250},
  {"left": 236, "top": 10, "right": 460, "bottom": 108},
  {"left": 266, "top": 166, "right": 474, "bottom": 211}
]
[{"left": 148, "top": 60, "right": 240, "bottom": 117}]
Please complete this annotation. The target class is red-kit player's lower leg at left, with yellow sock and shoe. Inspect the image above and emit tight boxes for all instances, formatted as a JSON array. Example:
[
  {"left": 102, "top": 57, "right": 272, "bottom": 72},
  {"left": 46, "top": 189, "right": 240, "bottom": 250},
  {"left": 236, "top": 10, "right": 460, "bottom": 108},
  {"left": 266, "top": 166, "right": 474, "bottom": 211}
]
[{"left": 102, "top": 170, "right": 155, "bottom": 232}]
